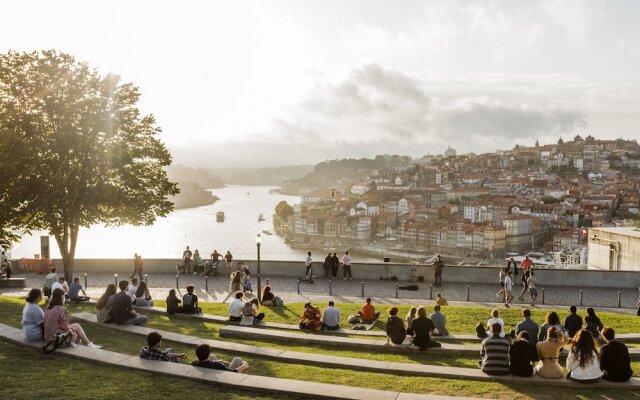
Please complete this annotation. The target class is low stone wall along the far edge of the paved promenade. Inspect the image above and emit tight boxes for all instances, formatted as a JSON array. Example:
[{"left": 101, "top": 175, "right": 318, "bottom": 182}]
[{"left": 13, "top": 259, "right": 640, "bottom": 289}]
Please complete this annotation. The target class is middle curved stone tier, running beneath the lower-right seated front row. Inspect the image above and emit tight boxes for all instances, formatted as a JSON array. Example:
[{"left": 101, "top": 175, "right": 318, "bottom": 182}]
[{"left": 72, "top": 313, "right": 640, "bottom": 388}]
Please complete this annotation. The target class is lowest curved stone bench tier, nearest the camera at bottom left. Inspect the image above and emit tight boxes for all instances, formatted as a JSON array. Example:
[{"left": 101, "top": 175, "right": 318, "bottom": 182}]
[{"left": 0, "top": 324, "right": 484, "bottom": 400}]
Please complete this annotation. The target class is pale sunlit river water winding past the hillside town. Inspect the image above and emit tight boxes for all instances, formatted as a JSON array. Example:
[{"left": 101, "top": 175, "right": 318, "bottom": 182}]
[{"left": 11, "top": 185, "right": 378, "bottom": 261}]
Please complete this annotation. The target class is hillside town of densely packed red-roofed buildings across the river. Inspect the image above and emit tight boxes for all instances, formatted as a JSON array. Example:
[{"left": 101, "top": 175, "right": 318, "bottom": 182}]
[{"left": 276, "top": 135, "right": 640, "bottom": 260}]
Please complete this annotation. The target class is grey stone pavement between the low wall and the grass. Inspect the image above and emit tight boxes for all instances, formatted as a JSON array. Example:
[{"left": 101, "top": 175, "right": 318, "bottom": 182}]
[{"left": 0, "top": 271, "right": 638, "bottom": 314}]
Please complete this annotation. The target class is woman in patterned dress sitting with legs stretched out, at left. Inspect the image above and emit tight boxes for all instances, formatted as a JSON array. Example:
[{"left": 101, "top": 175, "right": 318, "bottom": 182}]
[{"left": 43, "top": 289, "right": 101, "bottom": 349}]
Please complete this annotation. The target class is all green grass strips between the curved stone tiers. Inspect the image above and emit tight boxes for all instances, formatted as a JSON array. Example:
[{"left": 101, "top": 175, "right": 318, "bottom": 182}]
[{"left": 0, "top": 297, "right": 640, "bottom": 399}]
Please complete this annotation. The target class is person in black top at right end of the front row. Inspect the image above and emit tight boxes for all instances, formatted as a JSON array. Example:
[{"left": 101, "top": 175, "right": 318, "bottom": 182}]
[{"left": 600, "top": 326, "right": 633, "bottom": 382}]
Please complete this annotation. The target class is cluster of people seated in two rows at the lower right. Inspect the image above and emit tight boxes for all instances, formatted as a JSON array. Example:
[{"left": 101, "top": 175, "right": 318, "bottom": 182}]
[{"left": 478, "top": 306, "right": 633, "bottom": 383}]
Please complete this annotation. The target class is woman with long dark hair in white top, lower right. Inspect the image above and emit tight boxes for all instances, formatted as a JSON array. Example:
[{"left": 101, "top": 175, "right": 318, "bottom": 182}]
[{"left": 567, "top": 329, "right": 602, "bottom": 383}]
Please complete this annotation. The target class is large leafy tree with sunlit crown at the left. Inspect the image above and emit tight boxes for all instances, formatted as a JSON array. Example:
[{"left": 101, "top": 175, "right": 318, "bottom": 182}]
[{"left": 0, "top": 50, "right": 178, "bottom": 279}]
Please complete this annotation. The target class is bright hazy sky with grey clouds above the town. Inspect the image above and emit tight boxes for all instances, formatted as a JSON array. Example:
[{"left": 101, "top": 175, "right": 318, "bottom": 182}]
[{"left": 0, "top": 0, "right": 640, "bottom": 167}]
